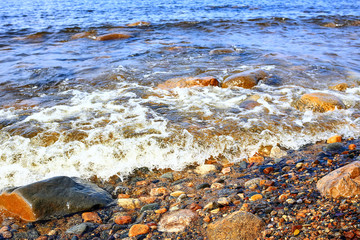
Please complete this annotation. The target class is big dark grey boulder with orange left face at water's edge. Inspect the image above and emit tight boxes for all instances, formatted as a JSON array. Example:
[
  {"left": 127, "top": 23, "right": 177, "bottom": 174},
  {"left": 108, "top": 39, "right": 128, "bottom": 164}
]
[{"left": 0, "top": 176, "right": 113, "bottom": 221}]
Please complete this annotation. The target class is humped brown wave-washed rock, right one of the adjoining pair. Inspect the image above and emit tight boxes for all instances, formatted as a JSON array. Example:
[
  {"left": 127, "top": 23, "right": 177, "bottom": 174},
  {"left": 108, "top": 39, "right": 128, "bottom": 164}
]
[{"left": 221, "top": 69, "right": 268, "bottom": 89}]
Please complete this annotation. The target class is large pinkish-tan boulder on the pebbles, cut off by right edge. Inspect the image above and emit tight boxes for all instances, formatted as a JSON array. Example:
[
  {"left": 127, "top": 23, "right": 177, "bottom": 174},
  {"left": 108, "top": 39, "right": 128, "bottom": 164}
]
[{"left": 316, "top": 161, "right": 360, "bottom": 198}]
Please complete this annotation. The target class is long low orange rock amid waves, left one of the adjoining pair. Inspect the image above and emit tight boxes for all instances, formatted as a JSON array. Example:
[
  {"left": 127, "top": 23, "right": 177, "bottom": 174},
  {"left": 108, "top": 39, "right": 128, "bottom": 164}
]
[{"left": 158, "top": 77, "right": 219, "bottom": 89}]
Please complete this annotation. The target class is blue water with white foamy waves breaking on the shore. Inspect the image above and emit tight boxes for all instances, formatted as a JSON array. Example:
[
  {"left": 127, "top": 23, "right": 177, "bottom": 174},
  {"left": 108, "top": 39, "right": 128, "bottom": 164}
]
[{"left": 0, "top": 0, "right": 360, "bottom": 186}]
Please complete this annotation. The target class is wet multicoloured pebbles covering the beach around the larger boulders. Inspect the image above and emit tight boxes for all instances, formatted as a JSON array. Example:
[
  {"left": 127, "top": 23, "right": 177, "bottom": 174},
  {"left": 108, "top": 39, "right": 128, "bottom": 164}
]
[{"left": 0, "top": 135, "right": 360, "bottom": 239}]
